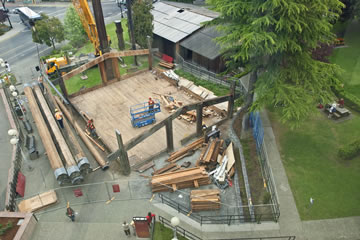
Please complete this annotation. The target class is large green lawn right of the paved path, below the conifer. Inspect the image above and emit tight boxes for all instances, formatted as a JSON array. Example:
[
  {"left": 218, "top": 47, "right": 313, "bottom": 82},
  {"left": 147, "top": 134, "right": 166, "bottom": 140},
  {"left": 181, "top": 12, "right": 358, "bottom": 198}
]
[{"left": 270, "top": 109, "right": 360, "bottom": 220}]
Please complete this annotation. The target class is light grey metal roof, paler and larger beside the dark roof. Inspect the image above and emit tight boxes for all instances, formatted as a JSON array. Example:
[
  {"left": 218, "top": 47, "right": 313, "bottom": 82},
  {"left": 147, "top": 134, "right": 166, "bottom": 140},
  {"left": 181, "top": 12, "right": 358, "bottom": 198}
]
[{"left": 151, "top": 2, "right": 213, "bottom": 43}]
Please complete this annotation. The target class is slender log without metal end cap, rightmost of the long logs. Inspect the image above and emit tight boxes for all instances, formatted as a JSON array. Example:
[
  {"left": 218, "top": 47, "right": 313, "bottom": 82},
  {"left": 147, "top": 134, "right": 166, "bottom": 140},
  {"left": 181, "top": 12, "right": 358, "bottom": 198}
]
[{"left": 55, "top": 98, "right": 109, "bottom": 170}]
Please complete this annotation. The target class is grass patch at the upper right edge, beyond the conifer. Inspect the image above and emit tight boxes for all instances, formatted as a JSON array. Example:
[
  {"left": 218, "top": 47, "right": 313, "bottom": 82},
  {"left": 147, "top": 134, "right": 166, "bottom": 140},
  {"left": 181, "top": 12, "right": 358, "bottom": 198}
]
[{"left": 330, "top": 22, "right": 360, "bottom": 98}]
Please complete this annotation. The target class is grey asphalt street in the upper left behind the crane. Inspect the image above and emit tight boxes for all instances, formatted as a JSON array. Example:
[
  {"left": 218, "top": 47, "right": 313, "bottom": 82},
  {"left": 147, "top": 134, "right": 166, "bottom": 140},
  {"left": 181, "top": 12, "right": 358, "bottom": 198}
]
[{"left": 0, "top": 1, "right": 125, "bottom": 83}]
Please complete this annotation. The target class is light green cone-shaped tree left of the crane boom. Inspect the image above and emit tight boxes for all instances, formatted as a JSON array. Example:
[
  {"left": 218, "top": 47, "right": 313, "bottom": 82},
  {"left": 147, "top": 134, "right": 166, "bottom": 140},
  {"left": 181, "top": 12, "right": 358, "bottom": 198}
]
[{"left": 64, "top": 5, "right": 87, "bottom": 47}]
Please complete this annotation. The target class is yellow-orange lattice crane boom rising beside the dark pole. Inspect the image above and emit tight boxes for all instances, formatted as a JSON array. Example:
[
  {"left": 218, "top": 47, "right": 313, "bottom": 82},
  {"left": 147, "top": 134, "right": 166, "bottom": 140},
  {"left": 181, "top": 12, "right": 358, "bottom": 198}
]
[{"left": 72, "top": 0, "right": 101, "bottom": 56}]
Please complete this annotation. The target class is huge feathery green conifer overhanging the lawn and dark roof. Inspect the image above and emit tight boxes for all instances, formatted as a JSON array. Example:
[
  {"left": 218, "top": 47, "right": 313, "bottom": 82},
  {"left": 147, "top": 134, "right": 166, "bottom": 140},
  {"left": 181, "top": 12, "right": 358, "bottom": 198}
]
[{"left": 208, "top": 0, "right": 344, "bottom": 126}]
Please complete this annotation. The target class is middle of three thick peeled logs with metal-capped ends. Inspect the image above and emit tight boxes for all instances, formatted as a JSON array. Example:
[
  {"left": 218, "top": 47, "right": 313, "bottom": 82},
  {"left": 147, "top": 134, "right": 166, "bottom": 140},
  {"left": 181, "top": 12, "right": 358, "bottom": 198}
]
[{"left": 34, "top": 86, "right": 82, "bottom": 183}]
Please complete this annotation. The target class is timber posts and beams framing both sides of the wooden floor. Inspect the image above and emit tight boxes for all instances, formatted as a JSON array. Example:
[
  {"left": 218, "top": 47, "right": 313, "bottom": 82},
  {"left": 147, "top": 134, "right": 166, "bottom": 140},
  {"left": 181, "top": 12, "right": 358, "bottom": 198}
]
[{"left": 54, "top": 49, "right": 237, "bottom": 175}]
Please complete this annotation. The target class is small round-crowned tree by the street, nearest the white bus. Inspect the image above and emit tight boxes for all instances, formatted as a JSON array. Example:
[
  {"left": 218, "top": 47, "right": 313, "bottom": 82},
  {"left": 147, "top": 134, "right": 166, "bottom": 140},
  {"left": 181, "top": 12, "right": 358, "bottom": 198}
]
[{"left": 32, "top": 14, "right": 65, "bottom": 49}]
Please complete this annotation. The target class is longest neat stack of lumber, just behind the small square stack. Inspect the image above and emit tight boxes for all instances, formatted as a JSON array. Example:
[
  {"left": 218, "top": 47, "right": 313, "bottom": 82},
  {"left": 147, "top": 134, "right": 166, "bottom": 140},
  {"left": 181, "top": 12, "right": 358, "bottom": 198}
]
[{"left": 151, "top": 167, "right": 211, "bottom": 192}]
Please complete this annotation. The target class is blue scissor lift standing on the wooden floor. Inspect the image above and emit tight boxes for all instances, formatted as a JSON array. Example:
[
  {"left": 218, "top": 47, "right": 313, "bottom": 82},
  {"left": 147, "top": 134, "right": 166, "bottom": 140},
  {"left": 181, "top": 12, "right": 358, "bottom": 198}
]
[{"left": 130, "top": 100, "right": 161, "bottom": 128}]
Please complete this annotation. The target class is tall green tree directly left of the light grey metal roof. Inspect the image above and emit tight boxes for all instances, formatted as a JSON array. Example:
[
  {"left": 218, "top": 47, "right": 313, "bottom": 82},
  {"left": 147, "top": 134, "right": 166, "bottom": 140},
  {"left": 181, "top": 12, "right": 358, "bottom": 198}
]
[{"left": 132, "top": 0, "right": 154, "bottom": 48}]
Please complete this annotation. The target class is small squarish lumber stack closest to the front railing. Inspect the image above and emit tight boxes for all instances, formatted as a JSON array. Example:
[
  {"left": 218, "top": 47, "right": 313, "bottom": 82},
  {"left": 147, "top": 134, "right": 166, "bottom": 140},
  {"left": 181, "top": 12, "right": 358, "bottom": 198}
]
[{"left": 190, "top": 189, "right": 220, "bottom": 212}]
